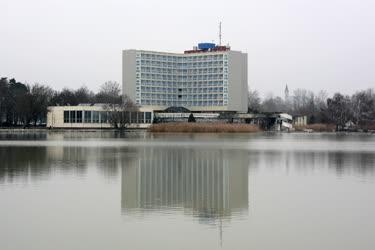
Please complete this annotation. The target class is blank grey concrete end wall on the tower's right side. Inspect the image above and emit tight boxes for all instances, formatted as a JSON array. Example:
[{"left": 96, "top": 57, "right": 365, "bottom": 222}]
[{"left": 228, "top": 51, "right": 248, "bottom": 112}]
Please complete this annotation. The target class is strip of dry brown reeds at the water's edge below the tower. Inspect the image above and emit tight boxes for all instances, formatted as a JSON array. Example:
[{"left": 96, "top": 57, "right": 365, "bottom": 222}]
[{"left": 149, "top": 123, "right": 261, "bottom": 133}]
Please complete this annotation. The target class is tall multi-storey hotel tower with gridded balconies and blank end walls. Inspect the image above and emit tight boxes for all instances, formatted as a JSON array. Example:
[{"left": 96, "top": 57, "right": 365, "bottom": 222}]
[{"left": 122, "top": 46, "right": 248, "bottom": 112}]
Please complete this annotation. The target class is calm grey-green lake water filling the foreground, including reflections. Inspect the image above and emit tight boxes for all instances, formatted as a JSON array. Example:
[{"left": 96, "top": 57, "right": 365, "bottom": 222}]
[{"left": 0, "top": 131, "right": 375, "bottom": 250}]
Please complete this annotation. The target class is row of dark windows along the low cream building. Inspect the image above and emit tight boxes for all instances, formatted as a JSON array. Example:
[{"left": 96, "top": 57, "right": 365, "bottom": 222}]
[{"left": 64, "top": 110, "right": 151, "bottom": 123}]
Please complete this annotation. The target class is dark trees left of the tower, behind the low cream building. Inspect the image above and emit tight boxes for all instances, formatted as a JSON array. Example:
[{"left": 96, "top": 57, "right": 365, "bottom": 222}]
[{"left": 0, "top": 77, "right": 123, "bottom": 127}]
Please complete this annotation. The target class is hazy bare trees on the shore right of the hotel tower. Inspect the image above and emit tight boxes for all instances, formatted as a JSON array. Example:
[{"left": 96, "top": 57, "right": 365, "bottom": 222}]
[{"left": 248, "top": 89, "right": 375, "bottom": 130}]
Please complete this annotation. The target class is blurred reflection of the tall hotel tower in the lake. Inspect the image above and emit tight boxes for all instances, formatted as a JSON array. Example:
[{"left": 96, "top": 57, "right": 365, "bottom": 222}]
[{"left": 121, "top": 148, "right": 249, "bottom": 223}]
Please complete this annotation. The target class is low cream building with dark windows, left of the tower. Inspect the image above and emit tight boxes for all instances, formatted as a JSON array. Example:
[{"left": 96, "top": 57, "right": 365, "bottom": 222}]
[{"left": 47, "top": 105, "right": 153, "bottom": 128}]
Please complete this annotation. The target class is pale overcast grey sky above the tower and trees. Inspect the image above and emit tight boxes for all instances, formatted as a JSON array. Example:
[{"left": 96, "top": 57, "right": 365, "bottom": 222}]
[{"left": 0, "top": 0, "right": 375, "bottom": 95}]
